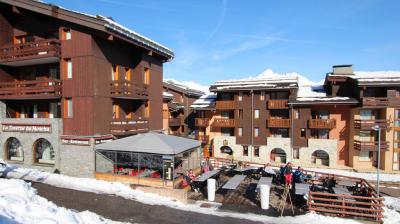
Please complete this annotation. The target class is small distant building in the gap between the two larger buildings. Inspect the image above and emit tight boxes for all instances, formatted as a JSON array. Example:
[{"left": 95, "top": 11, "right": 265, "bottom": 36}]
[{"left": 163, "top": 81, "right": 204, "bottom": 137}]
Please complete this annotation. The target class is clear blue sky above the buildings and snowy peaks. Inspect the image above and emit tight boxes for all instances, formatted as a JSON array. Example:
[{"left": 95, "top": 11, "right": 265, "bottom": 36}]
[{"left": 47, "top": 0, "right": 400, "bottom": 85}]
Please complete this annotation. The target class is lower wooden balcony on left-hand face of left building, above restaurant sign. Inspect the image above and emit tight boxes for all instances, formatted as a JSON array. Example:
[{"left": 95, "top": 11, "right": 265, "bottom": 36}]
[{"left": 0, "top": 80, "right": 62, "bottom": 100}]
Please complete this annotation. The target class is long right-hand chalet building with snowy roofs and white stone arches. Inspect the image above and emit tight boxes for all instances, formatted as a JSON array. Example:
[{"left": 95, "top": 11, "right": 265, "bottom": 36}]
[{"left": 191, "top": 65, "right": 400, "bottom": 172}]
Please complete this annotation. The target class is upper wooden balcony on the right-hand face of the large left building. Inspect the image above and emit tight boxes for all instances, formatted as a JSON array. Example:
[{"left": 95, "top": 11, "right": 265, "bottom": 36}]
[{"left": 110, "top": 80, "right": 149, "bottom": 99}]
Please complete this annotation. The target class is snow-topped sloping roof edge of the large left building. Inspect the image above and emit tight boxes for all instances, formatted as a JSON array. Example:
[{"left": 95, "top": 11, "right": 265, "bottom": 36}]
[{"left": 20, "top": 0, "right": 174, "bottom": 60}]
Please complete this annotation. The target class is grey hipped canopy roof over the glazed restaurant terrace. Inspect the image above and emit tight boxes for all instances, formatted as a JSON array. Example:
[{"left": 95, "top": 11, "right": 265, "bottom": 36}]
[{"left": 96, "top": 132, "right": 201, "bottom": 155}]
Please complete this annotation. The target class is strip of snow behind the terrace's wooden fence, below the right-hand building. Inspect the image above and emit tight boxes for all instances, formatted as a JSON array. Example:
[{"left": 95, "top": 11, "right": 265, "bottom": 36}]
[{"left": 304, "top": 168, "right": 400, "bottom": 182}]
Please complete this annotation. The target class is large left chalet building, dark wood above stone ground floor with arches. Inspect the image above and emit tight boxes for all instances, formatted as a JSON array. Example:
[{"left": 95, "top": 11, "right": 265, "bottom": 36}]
[{"left": 0, "top": 0, "right": 174, "bottom": 176}]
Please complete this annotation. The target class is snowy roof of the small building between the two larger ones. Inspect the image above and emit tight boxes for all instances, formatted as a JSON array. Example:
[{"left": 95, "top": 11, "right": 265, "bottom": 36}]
[{"left": 163, "top": 79, "right": 208, "bottom": 97}]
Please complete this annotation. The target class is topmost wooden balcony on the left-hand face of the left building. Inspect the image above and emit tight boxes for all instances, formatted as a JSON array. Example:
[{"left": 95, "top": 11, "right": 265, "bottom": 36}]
[{"left": 0, "top": 39, "right": 61, "bottom": 63}]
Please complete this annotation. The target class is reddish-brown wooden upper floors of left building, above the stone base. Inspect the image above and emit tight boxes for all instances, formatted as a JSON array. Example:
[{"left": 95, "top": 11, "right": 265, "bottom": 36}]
[{"left": 0, "top": 0, "right": 173, "bottom": 136}]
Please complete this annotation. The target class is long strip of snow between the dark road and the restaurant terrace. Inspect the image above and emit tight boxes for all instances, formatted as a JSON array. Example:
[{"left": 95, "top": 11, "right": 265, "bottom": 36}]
[{"left": 0, "top": 163, "right": 393, "bottom": 224}]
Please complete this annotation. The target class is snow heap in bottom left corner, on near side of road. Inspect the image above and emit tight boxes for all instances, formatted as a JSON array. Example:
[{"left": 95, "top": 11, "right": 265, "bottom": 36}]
[{"left": 0, "top": 179, "right": 122, "bottom": 224}]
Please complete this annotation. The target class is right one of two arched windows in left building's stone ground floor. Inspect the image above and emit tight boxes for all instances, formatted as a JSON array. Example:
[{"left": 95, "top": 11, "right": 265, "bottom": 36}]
[{"left": 33, "top": 138, "right": 55, "bottom": 164}]
